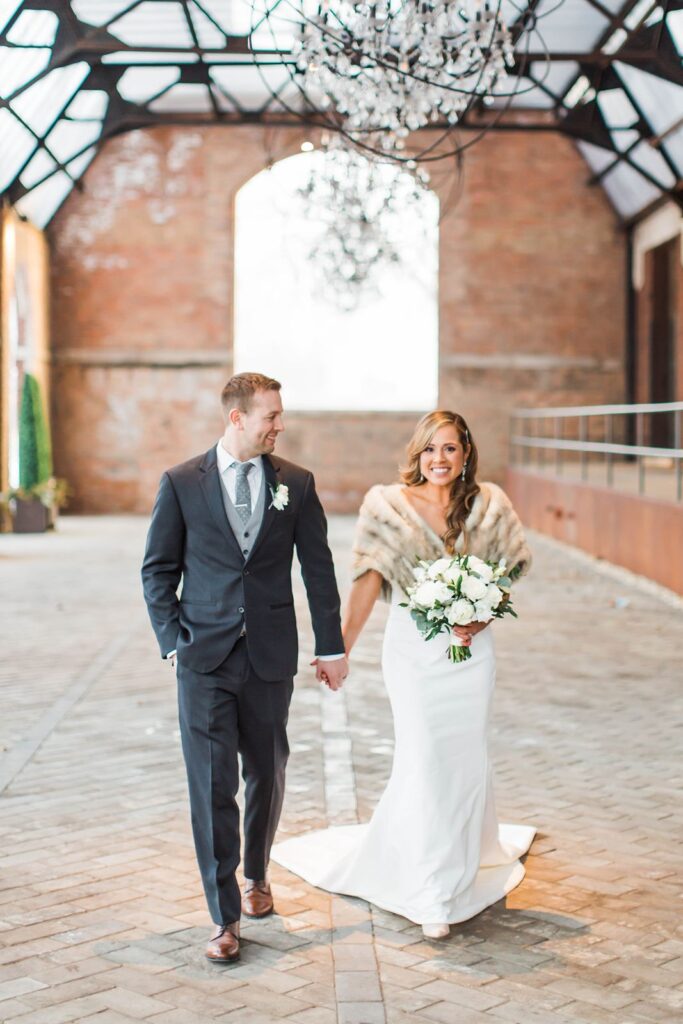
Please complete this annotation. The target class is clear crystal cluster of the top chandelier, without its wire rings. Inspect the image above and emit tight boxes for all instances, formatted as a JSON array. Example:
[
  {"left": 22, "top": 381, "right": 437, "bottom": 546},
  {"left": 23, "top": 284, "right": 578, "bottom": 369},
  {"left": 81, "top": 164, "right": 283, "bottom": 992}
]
[{"left": 294, "top": 0, "right": 514, "bottom": 154}]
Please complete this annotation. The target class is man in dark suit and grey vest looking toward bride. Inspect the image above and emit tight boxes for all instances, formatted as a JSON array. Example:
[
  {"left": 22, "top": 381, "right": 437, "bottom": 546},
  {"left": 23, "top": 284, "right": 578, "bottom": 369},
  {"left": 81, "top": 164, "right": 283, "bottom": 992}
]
[{"left": 142, "top": 374, "right": 348, "bottom": 963}]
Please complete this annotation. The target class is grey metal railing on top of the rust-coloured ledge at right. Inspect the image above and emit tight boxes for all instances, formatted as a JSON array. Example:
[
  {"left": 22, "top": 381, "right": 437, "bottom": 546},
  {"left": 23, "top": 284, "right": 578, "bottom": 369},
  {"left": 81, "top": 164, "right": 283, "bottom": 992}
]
[{"left": 510, "top": 401, "right": 683, "bottom": 502}]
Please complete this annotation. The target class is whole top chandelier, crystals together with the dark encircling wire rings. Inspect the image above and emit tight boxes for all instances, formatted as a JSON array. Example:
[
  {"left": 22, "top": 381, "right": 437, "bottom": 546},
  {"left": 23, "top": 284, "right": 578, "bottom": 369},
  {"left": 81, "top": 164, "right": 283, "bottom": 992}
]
[{"left": 248, "top": 0, "right": 564, "bottom": 167}]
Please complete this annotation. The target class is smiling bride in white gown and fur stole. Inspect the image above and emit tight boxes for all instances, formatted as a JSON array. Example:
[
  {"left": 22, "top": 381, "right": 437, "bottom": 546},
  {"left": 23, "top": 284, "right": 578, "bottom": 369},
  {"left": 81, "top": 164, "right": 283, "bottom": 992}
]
[{"left": 272, "top": 412, "right": 535, "bottom": 938}]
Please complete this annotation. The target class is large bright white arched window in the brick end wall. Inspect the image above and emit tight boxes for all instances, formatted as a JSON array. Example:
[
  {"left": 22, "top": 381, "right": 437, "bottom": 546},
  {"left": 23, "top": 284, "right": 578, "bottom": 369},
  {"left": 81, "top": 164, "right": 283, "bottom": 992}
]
[{"left": 234, "top": 153, "right": 438, "bottom": 411}]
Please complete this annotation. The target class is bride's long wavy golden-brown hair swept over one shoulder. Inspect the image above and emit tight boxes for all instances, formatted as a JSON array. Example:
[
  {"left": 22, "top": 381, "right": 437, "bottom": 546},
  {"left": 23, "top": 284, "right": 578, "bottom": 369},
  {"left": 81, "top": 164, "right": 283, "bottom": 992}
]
[{"left": 400, "top": 410, "right": 480, "bottom": 552}]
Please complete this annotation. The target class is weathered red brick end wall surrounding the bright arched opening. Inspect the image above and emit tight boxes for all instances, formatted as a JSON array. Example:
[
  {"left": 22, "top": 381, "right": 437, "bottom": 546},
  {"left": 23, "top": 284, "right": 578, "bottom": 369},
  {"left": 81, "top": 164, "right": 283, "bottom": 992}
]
[{"left": 49, "top": 126, "right": 625, "bottom": 512}]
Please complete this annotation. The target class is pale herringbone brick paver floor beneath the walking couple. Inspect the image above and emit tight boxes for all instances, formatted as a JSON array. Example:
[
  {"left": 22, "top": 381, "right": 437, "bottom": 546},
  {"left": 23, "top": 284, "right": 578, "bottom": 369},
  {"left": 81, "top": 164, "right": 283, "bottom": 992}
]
[{"left": 0, "top": 517, "right": 683, "bottom": 1024}]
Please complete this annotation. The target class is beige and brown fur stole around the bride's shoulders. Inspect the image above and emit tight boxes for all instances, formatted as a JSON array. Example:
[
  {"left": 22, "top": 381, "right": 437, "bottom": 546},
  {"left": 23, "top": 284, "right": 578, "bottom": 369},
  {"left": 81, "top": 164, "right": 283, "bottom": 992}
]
[{"left": 351, "top": 483, "right": 531, "bottom": 600}]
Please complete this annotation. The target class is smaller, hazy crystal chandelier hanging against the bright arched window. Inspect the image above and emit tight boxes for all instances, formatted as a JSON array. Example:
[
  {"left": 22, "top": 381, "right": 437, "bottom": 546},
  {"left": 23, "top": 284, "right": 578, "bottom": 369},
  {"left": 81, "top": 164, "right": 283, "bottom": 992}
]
[{"left": 298, "top": 136, "right": 428, "bottom": 311}]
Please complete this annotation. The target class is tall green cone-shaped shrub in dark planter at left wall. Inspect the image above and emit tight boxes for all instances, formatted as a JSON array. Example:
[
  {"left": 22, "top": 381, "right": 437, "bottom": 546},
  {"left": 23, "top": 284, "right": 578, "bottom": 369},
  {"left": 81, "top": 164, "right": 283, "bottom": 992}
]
[{"left": 0, "top": 374, "right": 68, "bottom": 534}]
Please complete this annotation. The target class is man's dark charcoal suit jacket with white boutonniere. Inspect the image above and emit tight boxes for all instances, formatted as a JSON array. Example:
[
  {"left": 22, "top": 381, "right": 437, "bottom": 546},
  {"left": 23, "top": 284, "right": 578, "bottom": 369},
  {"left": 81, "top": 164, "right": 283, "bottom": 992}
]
[{"left": 142, "top": 447, "right": 344, "bottom": 681}]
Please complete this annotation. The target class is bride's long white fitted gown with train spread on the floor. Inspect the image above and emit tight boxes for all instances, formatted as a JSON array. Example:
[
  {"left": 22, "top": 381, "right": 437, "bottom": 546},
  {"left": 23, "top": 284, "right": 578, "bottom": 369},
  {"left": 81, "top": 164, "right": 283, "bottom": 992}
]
[{"left": 272, "top": 587, "right": 535, "bottom": 925}]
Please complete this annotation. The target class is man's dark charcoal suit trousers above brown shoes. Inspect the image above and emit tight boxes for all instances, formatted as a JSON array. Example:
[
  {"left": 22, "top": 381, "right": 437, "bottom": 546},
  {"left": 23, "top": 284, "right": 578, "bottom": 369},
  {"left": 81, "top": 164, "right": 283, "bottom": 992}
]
[{"left": 178, "top": 639, "right": 294, "bottom": 925}]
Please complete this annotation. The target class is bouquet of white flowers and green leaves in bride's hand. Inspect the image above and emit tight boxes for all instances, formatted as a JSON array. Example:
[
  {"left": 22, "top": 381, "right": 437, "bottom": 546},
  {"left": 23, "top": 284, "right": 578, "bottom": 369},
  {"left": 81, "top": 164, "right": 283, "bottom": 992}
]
[{"left": 401, "top": 555, "right": 517, "bottom": 664}]
